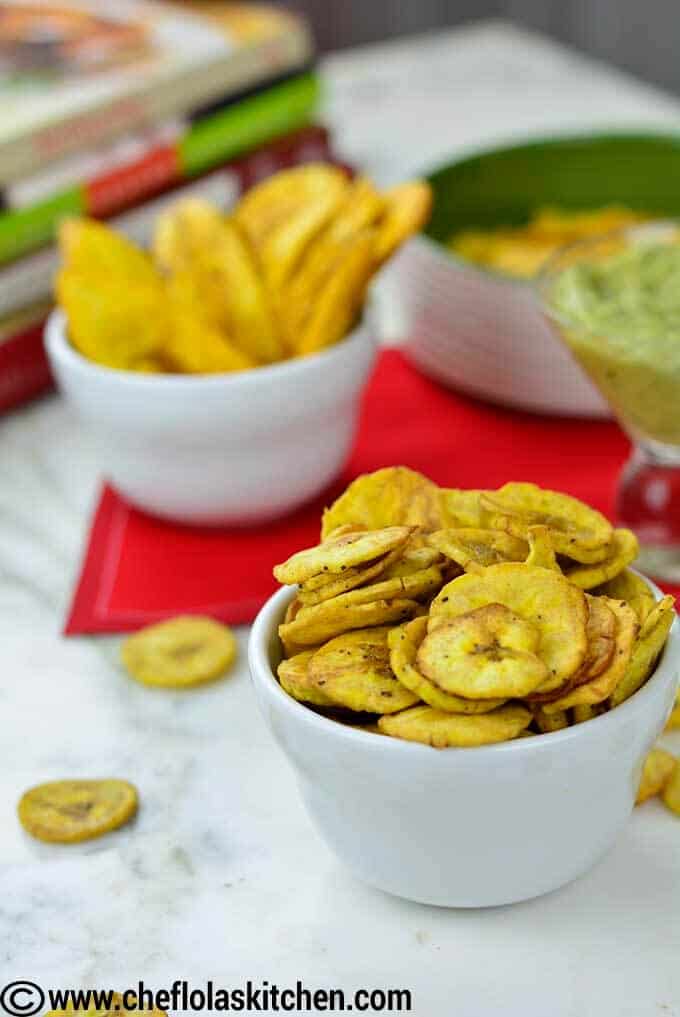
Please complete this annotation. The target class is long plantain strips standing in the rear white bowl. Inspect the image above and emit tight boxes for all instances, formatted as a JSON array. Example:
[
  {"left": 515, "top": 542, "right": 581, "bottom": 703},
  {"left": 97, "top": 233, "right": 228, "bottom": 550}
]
[{"left": 56, "top": 164, "right": 432, "bottom": 375}]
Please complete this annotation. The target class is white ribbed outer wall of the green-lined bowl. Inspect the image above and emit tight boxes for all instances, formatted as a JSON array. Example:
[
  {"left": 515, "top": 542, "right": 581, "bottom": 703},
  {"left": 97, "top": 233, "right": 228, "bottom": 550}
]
[{"left": 383, "top": 235, "right": 611, "bottom": 418}]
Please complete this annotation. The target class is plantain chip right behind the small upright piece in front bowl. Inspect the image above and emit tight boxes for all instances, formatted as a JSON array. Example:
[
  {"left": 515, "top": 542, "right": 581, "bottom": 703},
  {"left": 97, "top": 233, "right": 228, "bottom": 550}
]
[{"left": 480, "top": 483, "right": 614, "bottom": 562}]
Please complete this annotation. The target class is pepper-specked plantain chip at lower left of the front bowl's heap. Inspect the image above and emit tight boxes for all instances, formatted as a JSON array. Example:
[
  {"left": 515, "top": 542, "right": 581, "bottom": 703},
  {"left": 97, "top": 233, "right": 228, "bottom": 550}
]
[{"left": 309, "top": 627, "right": 419, "bottom": 713}]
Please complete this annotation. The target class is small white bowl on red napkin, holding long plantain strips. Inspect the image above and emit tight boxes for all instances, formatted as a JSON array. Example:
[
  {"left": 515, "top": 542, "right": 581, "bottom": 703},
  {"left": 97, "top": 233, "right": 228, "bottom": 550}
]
[{"left": 46, "top": 311, "right": 375, "bottom": 525}]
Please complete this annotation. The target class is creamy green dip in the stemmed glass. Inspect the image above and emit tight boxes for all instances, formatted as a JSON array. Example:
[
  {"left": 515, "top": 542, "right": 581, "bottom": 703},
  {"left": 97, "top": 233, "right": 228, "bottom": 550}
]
[{"left": 549, "top": 240, "right": 680, "bottom": 445}]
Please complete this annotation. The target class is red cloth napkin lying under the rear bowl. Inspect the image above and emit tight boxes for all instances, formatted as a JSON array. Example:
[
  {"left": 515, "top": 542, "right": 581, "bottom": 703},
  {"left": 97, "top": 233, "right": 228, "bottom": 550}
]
[{"left": 66, "top": 351, "right": 628, "bottom": 635}]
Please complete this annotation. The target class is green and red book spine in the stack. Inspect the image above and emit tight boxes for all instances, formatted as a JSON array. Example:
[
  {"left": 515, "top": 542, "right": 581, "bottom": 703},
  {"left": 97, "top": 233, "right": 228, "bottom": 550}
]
[{"left": 0, "top": 73, "right": 320, "bottom": 264}]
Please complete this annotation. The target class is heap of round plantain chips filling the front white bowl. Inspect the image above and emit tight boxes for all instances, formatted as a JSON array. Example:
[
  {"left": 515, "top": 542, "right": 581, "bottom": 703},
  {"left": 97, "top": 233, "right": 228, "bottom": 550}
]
[{"left": 268, "top": 467, "right": 680, "bottom": 756}]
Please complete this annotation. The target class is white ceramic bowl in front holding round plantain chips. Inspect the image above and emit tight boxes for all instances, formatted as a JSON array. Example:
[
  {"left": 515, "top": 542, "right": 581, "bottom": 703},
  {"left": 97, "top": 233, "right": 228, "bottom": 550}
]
[{"left": 249, "top": 587, "right": 680, "bottom": 907}]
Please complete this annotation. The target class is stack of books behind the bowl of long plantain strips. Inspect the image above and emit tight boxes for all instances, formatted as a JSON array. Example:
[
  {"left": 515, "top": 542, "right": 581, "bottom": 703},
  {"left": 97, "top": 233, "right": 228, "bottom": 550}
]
[{"left": 0, "top": 0, "right": 331, "bottom": 411}]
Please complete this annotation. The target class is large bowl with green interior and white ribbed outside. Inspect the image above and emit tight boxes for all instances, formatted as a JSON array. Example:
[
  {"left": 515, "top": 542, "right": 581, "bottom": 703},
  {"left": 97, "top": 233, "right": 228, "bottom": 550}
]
[{"left": 392, "top": 132, "right": 680, "bottom": 417}]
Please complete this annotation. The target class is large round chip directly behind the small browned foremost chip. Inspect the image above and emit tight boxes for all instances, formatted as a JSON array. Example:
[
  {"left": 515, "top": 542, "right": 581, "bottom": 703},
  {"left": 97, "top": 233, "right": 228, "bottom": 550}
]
[{"left": 429, "top": 562, "right": 588, "bottom": 692}]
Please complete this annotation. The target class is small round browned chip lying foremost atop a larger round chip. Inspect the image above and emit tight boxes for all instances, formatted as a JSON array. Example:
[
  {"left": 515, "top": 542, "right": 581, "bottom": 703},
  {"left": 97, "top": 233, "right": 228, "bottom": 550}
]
[{"left": 417, "top": 603, "right": 549, "bottom": 699}]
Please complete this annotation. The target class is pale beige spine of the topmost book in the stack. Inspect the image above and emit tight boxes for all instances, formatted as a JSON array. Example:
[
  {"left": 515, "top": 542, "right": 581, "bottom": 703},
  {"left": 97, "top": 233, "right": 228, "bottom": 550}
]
[{"left": 0, "top": 17, "right": 313, "bottom": 186}]
